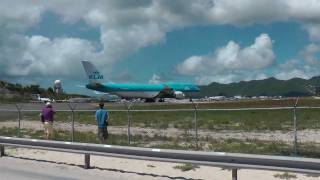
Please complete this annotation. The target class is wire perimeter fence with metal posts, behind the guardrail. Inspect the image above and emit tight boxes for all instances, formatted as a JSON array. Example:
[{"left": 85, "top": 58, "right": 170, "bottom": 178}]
[{"left": 0, "top": 101, "right": 320, "bottom": 157}]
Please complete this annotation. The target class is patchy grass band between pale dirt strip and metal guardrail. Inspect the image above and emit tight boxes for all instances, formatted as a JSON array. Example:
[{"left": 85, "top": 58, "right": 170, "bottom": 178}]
[{"left": 0, "top": 128, "right": 320, "bottom": 158}]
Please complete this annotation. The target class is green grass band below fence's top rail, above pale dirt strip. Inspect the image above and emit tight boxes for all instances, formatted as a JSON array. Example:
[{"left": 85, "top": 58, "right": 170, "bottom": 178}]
[{"left": 16, "top": 109, "right": 320, "bottom": 131}]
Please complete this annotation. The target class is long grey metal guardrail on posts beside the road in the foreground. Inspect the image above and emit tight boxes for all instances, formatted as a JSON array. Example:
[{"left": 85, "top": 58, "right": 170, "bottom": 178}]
[{"left": 0, "top": 136, "right": 320, "bottom": 180}]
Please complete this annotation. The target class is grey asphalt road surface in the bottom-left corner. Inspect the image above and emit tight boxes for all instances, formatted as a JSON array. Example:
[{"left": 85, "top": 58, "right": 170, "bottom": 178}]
[{"left": 0, "top": 157, "right": 139, "bottom": 180}]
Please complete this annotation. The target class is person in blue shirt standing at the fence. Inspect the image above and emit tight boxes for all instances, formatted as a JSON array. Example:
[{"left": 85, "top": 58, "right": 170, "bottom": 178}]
[{"left": 96, "top": 103, "right": 109, "bottom": 144}]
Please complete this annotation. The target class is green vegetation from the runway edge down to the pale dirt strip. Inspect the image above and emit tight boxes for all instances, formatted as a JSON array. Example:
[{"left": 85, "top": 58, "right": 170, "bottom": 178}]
[{"left": 6, "top": 99, "right": 320, "bottom": 131}]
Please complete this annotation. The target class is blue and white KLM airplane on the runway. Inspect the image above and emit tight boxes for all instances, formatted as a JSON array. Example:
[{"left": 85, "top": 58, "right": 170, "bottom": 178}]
[{"left": 81, "top": 61, "right": 200, "bottom": 102}]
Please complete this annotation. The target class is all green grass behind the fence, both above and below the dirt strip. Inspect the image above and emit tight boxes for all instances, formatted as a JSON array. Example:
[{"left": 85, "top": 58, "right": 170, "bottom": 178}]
[{"left": 0, "top": 98, "right": 320, "bottom": 158}]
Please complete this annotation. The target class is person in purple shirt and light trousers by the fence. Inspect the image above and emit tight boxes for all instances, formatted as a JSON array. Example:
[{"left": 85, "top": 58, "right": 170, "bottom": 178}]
[{"left": 41, "top": 102, "right": 55, "bottom": 139}]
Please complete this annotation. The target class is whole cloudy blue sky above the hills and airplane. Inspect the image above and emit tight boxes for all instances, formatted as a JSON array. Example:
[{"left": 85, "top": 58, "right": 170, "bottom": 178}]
[{"left": 0, "top": 0, "right": 320, "bottom": 93}]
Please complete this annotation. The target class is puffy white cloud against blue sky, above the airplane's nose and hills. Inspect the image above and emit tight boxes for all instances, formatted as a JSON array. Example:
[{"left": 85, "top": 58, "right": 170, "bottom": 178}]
[{"left": 176, "top": 34, "right": 275, "bottom": 84}]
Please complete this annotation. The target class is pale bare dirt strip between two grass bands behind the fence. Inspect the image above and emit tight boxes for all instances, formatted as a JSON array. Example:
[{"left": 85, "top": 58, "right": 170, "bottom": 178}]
[{"left": 0, "top": 120, "right": 320, "bottom": 144}]
